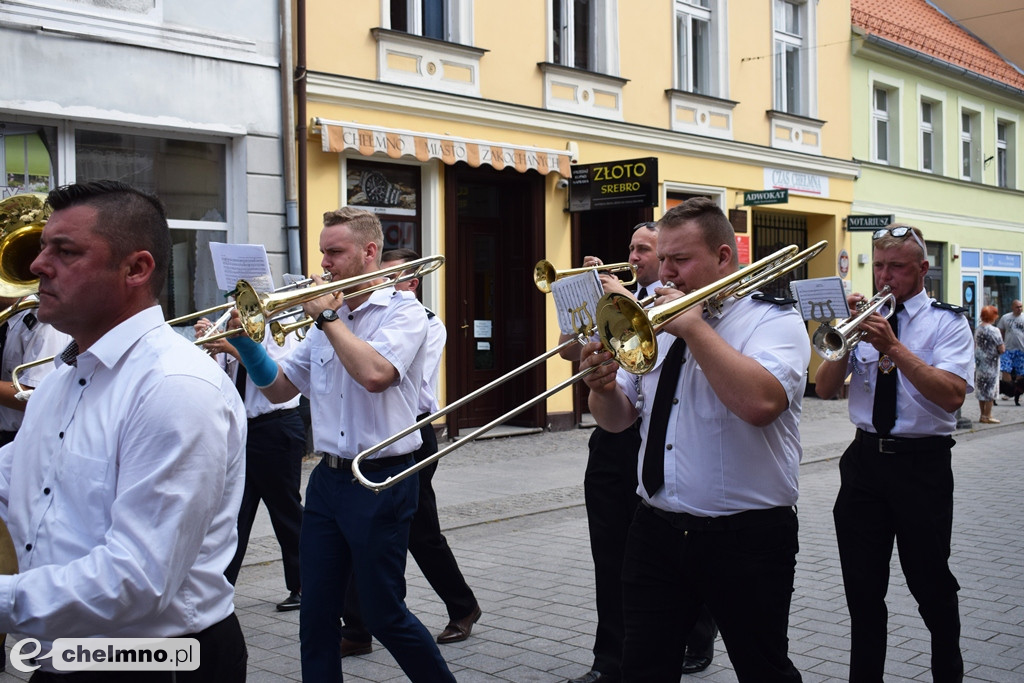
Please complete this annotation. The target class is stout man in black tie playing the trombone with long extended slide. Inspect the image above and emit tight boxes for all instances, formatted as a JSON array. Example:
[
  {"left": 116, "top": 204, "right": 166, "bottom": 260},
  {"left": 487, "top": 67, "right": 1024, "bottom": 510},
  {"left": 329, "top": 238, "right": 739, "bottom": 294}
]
[{"left": 581, "top": 198, "right": 810, "bottom": 683}]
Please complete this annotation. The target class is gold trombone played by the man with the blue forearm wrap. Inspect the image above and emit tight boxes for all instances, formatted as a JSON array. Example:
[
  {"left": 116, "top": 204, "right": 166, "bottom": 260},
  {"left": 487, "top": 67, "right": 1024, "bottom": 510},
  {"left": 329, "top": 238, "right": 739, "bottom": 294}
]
[{"left": 234, "top": 254, "right": 444, "bottom": 342}]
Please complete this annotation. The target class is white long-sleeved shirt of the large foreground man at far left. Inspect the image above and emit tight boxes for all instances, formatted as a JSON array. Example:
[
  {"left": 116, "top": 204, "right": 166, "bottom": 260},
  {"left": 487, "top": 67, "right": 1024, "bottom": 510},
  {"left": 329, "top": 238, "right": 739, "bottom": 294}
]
[{"left": 0, "top": 306, "right": 246, "bottom": 666}]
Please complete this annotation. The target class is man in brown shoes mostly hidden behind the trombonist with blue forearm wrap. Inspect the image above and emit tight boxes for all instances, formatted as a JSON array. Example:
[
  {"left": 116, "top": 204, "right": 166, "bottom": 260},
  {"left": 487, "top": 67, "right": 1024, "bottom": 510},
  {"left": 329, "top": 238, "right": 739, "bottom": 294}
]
[{"left": 341, "top": 249, "right": 480, "bottom": 657}]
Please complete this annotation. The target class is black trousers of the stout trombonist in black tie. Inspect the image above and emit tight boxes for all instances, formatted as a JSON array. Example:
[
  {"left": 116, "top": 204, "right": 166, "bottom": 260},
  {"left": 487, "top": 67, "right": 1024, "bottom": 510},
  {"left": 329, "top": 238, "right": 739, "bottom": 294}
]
[{"left": 623, "top": 505, "right": 801, "bottom": 683}]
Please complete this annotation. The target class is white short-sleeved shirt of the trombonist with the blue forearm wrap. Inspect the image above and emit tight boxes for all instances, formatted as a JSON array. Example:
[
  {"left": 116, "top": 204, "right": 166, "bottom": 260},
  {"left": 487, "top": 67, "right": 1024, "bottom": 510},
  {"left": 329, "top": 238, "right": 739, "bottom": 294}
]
[{"left": 279, "top": 287, "right": 427, "bottom": 458}]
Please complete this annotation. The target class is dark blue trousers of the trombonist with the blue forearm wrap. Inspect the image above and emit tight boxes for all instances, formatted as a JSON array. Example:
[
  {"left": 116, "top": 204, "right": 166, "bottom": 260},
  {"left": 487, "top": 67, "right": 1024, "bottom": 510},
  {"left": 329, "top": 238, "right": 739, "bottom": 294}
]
[{"left": 299, "top": 463, "right": 455, "bottom": 683}]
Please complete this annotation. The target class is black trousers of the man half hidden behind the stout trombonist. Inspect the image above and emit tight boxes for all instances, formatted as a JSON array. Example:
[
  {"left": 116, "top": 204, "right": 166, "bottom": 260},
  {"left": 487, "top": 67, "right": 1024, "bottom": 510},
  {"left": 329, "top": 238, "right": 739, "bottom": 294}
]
[{"left": 583, "top": 426, "right": 718, "bottom": 676}]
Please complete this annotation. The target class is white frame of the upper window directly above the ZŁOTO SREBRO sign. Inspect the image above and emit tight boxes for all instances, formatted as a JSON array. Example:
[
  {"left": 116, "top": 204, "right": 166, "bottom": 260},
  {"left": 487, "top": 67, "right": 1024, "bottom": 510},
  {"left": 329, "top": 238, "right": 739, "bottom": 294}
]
[{"left": 548, "top": 0, "right": 618, "bottom": 76}]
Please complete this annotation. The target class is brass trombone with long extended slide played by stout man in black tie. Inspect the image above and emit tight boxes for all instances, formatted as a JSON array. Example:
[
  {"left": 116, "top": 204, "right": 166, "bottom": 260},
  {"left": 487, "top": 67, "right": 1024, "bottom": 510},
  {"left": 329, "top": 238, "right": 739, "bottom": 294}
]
[{"left": 352, "top": 241, "right": 828, "bottom": 494}]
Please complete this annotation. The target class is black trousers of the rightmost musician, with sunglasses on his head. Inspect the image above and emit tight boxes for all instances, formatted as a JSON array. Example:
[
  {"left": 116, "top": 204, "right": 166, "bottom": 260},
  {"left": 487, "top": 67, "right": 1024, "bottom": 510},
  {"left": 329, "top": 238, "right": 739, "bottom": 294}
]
[{"left": 833, "top": 438, "right": 964, "bottom": 683}]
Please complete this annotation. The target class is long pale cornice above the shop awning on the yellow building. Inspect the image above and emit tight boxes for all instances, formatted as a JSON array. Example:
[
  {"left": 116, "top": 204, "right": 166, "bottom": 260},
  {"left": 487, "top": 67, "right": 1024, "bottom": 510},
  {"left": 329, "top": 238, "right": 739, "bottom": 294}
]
[{"left": 306, "top": 72, "right": 859, "bottom": 180}]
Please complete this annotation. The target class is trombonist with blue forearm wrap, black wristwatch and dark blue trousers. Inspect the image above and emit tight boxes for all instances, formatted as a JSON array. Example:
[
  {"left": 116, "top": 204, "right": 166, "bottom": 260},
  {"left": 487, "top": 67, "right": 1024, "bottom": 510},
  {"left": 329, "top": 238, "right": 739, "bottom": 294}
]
[{"left": 231, "top": 207, "right": 455, "bottom": 683}]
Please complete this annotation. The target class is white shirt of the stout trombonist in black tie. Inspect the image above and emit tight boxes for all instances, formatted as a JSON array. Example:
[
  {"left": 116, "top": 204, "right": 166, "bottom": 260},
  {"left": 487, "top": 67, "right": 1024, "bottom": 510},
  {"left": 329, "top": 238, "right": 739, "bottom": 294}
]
[{"left": 617, "top": 297, "right": 811, "bottom": 517}]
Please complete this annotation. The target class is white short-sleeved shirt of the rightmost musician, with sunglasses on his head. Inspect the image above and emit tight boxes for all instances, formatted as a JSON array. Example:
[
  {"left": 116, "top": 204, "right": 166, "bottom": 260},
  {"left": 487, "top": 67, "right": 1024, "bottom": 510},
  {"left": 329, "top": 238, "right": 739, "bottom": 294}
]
[{"left": 847, "top": 290, "right": 974, "bottom": 437}]
